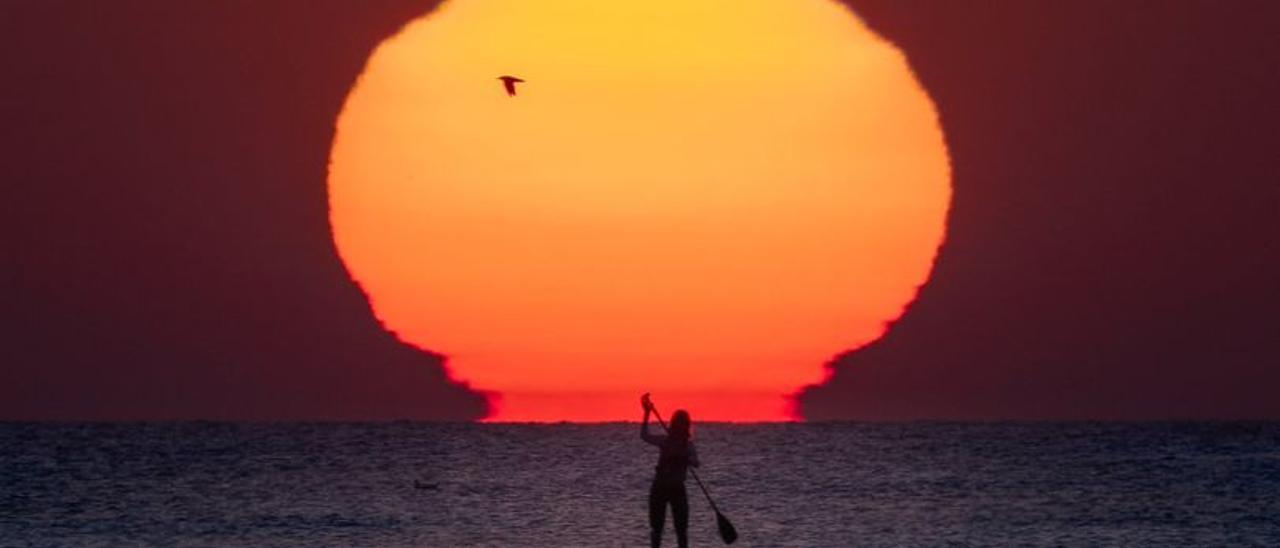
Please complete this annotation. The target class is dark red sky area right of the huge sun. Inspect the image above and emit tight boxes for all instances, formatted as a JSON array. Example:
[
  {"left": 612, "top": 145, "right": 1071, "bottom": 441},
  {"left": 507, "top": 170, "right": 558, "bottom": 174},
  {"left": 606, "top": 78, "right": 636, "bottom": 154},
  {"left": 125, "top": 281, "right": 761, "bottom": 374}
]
[{"left": 801, "top": 0, "right": 1280, "bottom": 419}]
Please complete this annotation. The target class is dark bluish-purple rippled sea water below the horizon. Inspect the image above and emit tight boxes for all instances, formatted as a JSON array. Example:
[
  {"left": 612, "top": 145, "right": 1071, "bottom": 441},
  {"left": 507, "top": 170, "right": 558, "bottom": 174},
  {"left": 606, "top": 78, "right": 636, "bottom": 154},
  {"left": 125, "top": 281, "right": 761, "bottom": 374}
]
[{"left": 0, "top": 423, "right": 1280, "bottom": 547}]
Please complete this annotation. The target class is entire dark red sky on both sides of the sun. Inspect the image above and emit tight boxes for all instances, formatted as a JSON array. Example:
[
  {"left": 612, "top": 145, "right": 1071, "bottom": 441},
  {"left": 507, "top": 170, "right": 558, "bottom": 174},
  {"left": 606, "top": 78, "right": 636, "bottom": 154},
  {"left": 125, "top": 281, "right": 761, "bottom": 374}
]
[{"left": 0, "top": 0, "right": 1280, "bottom": 419}]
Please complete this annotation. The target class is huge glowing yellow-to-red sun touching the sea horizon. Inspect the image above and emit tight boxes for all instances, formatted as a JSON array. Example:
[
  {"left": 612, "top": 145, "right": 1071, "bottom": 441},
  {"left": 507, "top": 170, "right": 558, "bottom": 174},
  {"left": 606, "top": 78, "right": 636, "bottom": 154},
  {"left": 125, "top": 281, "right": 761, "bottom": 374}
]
[{"left": 329, "top": 0, "right": 951, "bottom": 421}]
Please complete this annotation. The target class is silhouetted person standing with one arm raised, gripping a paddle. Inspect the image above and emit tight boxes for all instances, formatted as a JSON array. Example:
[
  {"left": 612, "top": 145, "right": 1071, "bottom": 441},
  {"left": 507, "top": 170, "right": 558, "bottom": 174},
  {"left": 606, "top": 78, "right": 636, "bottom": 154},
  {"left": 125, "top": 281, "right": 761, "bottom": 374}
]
[{"left": 640, "top": 394, "right": 699, "bottom": 548}]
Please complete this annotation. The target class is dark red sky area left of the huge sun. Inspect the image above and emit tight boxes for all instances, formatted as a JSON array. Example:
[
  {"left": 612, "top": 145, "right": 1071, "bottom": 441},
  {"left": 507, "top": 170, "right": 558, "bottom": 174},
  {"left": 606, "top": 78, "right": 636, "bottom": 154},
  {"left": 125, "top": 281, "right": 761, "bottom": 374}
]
[{"left": 0, "top": 0, "right": 485, "bottom": 419}]
